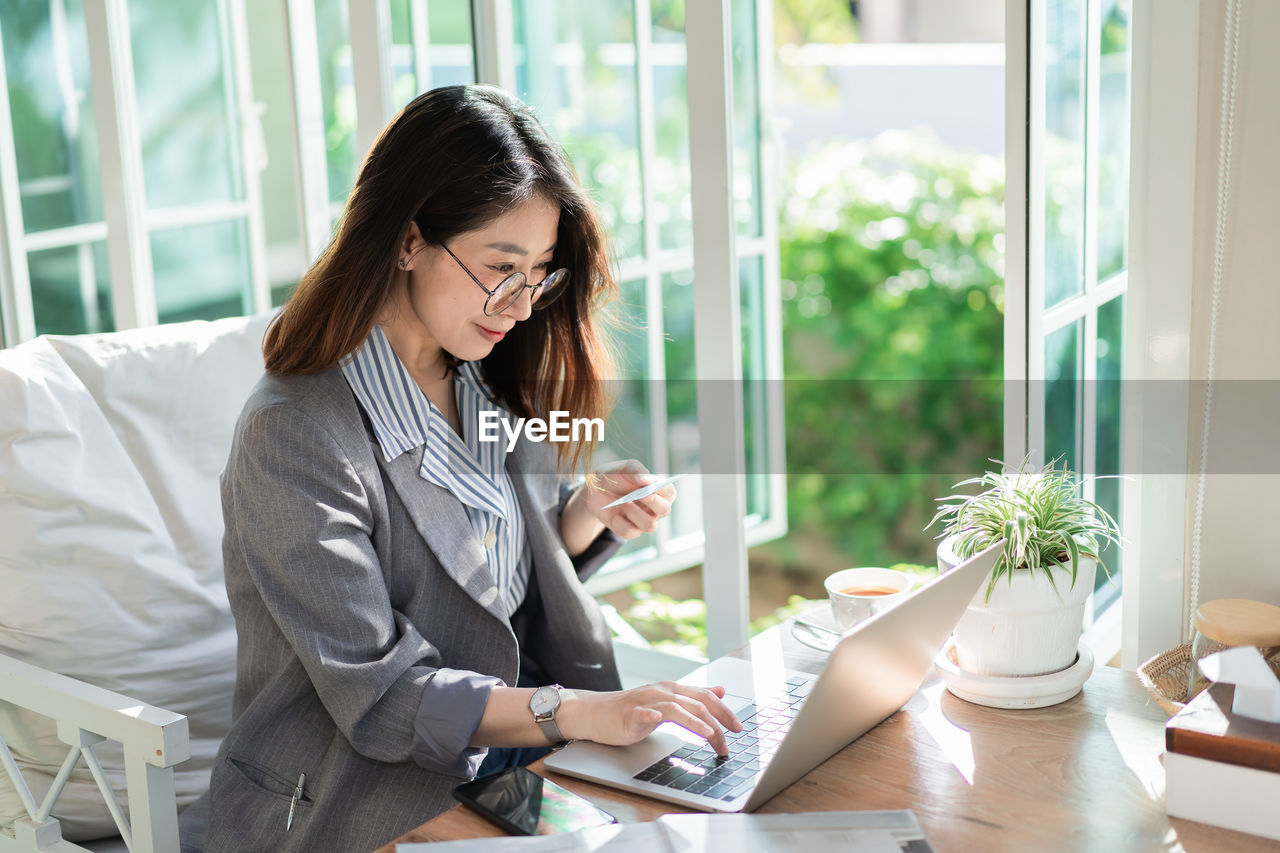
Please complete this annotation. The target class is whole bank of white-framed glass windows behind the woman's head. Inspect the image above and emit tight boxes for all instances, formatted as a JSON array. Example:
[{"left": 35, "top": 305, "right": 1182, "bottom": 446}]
[{"left": 0, "top": 0, "right": 785, "bottom": 666}]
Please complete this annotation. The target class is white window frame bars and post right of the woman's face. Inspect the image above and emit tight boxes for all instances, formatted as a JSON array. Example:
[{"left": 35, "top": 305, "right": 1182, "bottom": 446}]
[{"left": 588, "top": 0, "right": 787, "bottom": 657}]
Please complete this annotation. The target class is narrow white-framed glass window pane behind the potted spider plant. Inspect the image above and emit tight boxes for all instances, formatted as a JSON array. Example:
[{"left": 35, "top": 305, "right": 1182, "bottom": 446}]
[{"left": 1006, "top": 0, "right": 1130, "bottom": 657}]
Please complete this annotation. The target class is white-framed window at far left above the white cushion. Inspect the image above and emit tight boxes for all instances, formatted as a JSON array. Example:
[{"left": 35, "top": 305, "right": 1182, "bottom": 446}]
[{"left": 0, "top": 0, "right": 268, "bottom": 343}]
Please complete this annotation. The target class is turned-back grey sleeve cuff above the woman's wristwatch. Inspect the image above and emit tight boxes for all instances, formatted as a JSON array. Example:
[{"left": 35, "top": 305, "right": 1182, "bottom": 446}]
[{"left": 412, "top": 670, "right": 503, "bottom": 779}]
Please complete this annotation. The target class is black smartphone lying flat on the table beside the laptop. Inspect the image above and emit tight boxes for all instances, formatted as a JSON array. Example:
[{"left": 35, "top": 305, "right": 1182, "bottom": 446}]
[{"left": 453, "top": 767, "right": 618, "bottom": 835}]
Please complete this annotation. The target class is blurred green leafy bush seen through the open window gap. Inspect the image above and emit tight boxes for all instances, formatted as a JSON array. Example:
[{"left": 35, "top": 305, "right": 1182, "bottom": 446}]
[{"left": 771, "top": 132, "right": 1004, "bottom": 574}]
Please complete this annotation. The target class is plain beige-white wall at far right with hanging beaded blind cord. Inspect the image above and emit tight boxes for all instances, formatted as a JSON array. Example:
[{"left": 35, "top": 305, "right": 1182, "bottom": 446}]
[{"left": 1187, "top": 0, "right": 1280, "bottom": 606}]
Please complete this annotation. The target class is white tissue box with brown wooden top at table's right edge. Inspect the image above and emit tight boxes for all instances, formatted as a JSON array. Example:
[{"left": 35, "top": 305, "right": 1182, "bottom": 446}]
[{"left": 1165, "top": 684, "right": 1280, "bottom": 840}]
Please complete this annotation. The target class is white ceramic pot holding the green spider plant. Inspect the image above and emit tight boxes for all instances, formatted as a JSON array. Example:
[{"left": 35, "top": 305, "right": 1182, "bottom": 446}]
[{"left": 938, "top": 539, "right": 1098, "bottom": 675}]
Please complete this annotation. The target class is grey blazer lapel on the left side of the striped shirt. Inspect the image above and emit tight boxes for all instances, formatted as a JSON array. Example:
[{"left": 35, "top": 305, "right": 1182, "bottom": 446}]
[{"left": 375, "top": 448, "right": 507, "bottom": 622}]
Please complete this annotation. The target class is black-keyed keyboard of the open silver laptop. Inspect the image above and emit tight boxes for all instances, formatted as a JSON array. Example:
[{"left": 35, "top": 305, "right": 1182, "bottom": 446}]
[{"left": 632, "top": 676, "right": 818, "bottom": 800}]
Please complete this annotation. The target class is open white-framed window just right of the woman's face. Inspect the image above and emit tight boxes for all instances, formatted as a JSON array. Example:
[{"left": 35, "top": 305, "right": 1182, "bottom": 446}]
[{"left": 495, "top": 0, "right": 786, "bottom": 648}]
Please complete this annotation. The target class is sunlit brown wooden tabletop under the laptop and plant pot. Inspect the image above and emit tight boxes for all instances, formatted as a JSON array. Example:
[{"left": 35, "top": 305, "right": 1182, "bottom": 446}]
[{"left": 376, "top": 625, "right": 1280, "bottom": 853}]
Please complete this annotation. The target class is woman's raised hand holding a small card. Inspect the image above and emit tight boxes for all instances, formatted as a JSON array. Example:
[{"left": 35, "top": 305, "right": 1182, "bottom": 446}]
[{"left": 561, "top": 459, "right": 676, "bottom": 555}]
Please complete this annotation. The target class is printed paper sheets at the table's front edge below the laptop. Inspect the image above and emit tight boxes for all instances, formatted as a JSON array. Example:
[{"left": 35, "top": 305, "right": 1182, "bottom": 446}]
[{"left": 396, "top": 809, "right": 933, "bottom": 853}]
